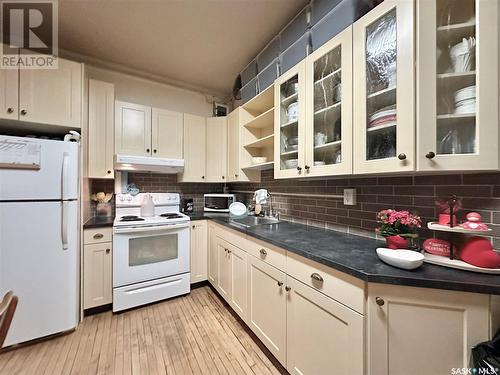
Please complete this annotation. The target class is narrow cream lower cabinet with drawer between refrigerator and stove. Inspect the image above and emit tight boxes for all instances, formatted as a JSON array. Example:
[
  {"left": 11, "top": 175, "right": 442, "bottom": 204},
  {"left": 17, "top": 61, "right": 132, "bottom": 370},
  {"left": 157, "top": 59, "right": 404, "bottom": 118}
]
[{"left": 83, "top": 228, "right": 113, "bottom": 309}]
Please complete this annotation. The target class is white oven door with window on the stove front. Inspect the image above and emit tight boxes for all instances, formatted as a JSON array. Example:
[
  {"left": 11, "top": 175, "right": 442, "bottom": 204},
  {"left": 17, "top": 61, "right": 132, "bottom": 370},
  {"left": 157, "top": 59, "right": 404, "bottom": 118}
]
[{"left": 113, "top": 223, "right": 189, "bottom": 288}]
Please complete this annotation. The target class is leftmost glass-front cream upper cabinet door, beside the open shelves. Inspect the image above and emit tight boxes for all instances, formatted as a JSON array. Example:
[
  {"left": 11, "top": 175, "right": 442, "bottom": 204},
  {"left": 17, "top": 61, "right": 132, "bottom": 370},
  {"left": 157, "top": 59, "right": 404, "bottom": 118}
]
[{"left": 274, "top": 61, "right": 306, "bottom": 178}]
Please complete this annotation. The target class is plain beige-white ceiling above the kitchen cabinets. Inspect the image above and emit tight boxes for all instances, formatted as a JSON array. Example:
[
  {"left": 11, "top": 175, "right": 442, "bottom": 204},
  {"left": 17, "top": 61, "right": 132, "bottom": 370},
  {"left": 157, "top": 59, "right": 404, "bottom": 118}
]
[{"left": 59, "top": 0, "right": 308, "bottom": 95}]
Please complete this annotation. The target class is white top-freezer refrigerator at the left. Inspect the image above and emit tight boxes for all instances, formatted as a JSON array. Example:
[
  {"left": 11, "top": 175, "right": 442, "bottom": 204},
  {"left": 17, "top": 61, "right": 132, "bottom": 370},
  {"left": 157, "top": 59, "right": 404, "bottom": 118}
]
[{"left": 0, "top": 135, "right": 80, "bottom": 347}]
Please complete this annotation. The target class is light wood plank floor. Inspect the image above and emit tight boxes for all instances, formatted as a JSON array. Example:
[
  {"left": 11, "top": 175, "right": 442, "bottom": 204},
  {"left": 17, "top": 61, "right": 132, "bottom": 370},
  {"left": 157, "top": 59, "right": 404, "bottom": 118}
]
[{"left": 0, "top": 287, "right": 283, "bottom": 375}]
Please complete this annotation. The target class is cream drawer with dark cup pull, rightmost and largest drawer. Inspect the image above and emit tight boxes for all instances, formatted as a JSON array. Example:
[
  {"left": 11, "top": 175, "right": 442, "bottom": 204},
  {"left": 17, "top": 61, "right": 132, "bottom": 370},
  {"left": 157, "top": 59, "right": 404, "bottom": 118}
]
[{"left": 286, "top": 252, "right": 365, "bottom": 314}]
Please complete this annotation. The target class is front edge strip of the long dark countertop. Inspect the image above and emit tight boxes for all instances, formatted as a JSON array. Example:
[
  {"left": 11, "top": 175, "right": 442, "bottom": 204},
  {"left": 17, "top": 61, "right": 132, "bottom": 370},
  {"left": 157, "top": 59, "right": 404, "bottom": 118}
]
[{"left": 195, "top": 215, "right": 500, "bottom": 295}]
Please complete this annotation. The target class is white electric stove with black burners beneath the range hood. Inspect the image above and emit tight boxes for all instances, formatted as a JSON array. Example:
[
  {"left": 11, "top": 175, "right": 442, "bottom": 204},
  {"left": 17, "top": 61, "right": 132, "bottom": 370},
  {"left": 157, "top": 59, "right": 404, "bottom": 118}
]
[{"left": 113, "top": 193, "right": 190, "bottom": 311}]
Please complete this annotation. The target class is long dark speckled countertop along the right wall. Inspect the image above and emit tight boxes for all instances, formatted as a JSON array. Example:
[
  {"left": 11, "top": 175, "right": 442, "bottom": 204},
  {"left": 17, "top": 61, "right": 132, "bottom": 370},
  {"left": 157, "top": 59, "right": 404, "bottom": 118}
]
[{"left": 190, "top": 212, "right": 500, "bottom": 295}]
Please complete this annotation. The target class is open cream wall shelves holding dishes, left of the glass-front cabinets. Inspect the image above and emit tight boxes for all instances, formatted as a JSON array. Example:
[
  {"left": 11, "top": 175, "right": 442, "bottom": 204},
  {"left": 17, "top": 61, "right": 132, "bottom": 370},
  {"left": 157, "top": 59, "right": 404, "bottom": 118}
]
[{"left": 241, "top": 85, "right": 274, "bottom": 171}]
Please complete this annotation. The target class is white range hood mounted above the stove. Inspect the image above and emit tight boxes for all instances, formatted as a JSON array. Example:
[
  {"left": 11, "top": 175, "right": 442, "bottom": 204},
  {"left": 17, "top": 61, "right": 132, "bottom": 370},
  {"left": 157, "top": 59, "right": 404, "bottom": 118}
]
[{"left": 115, "top": 154, "right": 184, "bottom": 174}]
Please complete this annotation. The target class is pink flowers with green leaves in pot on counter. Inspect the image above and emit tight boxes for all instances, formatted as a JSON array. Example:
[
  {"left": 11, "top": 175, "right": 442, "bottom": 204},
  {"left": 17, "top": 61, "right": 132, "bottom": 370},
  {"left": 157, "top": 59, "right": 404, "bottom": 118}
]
[{"left": 376, "top": 209, "right": 422, "bottom": 237}]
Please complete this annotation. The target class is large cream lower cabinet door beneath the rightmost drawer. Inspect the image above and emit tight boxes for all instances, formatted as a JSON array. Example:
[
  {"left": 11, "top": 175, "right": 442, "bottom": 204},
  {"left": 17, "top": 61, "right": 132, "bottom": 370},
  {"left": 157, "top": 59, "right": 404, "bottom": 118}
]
[{"left": 286, "top": 276, "right": 364, "bottom": 375}]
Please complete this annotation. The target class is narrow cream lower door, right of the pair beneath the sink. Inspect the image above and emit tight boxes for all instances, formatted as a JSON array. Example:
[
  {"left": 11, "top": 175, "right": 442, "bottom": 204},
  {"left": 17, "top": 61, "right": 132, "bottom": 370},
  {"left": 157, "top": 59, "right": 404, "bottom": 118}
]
[{"left": 229, "top": 245, "right": 248, "bottom": 321}]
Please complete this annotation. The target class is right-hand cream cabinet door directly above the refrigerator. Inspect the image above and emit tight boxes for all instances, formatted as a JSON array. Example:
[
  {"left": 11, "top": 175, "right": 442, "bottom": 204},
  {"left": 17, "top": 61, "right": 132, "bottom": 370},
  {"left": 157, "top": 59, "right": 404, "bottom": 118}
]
[{"left": 18, "top": 58, "right": 83, "bottom": 128}]
